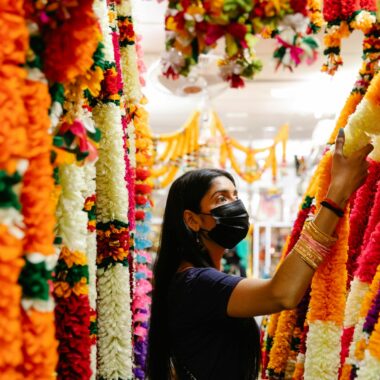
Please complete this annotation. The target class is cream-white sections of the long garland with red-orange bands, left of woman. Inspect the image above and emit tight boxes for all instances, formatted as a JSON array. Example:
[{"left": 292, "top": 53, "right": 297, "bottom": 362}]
[{"left": 93, "top": 0, "right": 133, "bottom": 379}]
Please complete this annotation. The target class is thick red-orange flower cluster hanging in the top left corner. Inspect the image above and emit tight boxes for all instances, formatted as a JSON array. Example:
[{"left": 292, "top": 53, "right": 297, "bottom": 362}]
[{"left": 25, "top": 0, "right": 99, "bottom": 83}]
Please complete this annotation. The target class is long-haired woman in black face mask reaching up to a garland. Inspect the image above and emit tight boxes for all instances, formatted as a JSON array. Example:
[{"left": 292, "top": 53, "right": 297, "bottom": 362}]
[{"left": 147, "top": 130, "right": 373, "bottom": 380}]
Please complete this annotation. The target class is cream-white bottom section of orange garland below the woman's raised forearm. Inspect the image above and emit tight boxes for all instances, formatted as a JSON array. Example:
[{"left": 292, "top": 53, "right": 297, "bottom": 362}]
[{"left": 305, "top": 321, "right": 341, "bottom": 380}]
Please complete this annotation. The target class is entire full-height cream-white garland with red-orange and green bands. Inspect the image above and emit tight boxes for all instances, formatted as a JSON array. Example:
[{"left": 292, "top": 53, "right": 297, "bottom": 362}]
[{"left": 93, "top": 0, "right": 132, "bottom": 379}]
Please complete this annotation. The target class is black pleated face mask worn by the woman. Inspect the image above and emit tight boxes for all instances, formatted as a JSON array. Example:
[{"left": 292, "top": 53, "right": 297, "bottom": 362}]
[{"left": 203, "top": 199, "right": 249, "bottom": 249}]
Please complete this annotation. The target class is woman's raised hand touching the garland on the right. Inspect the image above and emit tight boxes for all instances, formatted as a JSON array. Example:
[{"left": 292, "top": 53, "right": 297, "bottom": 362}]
[{"left": 327, "top": 129, "right": 373, "bottom": 208}]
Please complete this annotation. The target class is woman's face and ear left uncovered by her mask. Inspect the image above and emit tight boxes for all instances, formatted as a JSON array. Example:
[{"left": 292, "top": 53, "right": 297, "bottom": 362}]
[{"left": 184, "top": 176, "right": 238, "bottom": 231}]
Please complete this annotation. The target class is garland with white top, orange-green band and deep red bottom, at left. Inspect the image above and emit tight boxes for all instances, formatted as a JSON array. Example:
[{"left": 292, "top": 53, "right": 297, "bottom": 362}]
[{"left": 54, "top": 164, "right": 91, "bottom": 379}]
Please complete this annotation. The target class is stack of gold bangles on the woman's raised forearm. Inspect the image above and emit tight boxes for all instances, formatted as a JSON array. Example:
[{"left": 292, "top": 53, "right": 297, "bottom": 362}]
[{"left": 293, "top": 221, "right": 337, "bottom": 270}]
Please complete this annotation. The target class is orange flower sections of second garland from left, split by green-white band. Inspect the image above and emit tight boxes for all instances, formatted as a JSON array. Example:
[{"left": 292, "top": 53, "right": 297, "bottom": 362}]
[{"left": 21, "top": 81, "right": 58, "bottom": 379}]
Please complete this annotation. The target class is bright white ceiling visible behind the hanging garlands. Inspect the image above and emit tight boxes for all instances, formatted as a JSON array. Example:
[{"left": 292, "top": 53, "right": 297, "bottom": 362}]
[{"left": 133, "top": 0, "right": 361, "bottom": 140}]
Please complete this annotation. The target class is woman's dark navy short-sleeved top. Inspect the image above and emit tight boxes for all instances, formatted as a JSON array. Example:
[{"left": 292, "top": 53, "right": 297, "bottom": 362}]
[{"left": 169, "top": 268, "right": 254, "bottom": 380}]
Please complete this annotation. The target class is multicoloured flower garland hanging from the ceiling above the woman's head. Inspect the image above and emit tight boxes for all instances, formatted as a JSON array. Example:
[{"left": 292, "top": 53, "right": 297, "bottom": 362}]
[{"left": 162, "top": 0, "right": 262, "bottom": 88}]
